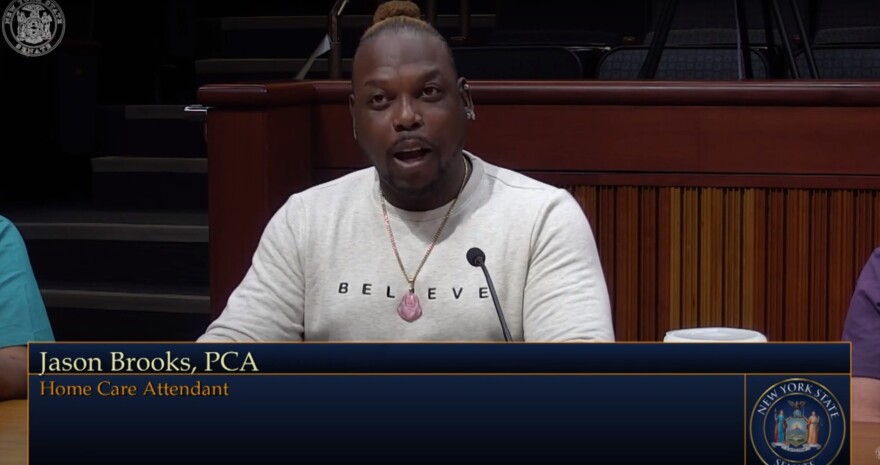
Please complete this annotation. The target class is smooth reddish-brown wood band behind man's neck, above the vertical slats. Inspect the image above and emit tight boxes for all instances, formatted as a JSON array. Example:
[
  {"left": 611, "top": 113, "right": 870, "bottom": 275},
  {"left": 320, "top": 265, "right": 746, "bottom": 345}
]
[{"left": 315, "top": 105, "right": 876, "bottom": 181}]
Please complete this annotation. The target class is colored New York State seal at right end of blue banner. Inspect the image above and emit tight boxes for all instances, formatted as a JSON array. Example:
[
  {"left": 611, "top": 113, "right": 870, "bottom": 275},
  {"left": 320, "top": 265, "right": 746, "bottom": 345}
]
[{"left": 749, "top": 378, "right": 846, "bottom": 465}]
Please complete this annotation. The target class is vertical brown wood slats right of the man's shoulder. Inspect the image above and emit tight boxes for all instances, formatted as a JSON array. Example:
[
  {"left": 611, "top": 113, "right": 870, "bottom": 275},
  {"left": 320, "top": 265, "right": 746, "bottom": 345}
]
[{"left": 567, "top": 186, "right": 880, "bottom": 341}]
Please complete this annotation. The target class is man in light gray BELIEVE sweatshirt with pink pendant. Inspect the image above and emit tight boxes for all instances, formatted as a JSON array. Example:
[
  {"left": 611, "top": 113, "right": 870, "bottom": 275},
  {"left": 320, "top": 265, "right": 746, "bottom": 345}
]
[{"left": 199, "top": 2, "right": 614, "bottom": 341}]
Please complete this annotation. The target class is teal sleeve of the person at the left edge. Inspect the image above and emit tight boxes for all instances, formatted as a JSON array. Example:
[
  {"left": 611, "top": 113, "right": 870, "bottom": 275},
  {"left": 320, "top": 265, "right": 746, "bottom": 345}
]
[{"left": 0, "top": 216, "right": 55, "bottom": 347}]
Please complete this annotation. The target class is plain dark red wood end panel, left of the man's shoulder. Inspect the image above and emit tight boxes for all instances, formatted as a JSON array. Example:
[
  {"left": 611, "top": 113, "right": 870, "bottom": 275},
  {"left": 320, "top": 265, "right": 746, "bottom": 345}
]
[{"left": 208, "top": 106, "right": 312, "bottom": 315}]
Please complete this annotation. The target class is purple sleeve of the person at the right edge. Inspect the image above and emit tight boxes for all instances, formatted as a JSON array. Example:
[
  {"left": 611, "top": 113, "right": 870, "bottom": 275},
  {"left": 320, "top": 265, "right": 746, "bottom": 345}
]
[{"left": 843, "top": 248, "right": 880, "bottom": 379}]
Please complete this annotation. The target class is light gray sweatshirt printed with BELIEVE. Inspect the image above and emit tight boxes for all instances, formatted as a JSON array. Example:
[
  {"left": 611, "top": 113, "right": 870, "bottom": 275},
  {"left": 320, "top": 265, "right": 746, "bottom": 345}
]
[{"left": 199, "top": 153, "right": 614, "bottom": 341}]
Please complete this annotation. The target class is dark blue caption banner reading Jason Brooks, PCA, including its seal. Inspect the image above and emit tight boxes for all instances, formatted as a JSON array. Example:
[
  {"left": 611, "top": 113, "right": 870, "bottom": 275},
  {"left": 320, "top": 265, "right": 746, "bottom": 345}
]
[{"left": 29, "top": 344, "right": 850, "bottom": 465}]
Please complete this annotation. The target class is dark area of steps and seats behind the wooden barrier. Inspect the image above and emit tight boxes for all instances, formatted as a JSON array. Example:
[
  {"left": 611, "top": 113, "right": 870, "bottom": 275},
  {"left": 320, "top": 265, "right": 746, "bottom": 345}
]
[{"left": 0, "top": 0, "right": 880, "bottom": 340}]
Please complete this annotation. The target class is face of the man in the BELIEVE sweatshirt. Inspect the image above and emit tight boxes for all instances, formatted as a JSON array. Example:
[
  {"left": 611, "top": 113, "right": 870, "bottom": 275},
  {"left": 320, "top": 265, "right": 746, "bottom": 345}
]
[{"left": 349, "top": 31, "right": 470, "bottom": 198}]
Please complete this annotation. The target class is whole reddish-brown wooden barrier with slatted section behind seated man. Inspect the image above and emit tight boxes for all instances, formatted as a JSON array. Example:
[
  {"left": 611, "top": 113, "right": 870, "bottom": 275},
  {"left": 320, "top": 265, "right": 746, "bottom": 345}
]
[{"left": 199, "top": 81, "right": 880, "bottom": 341}]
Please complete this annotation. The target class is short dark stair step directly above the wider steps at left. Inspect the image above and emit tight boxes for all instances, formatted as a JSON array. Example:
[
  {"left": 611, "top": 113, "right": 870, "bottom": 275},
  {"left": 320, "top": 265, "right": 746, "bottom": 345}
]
[{"left": 92, "top": 157, "right": 208, "bottom": 210}]
